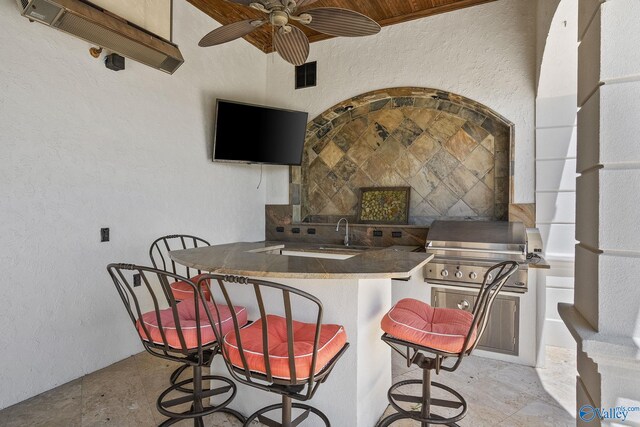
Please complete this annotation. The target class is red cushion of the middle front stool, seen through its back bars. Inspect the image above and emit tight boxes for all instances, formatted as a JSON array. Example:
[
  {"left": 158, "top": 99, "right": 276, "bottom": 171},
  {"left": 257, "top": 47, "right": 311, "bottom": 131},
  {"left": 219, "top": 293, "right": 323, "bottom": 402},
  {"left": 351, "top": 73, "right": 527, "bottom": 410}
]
[{"left": 223, "top": 315, "right": 347, "bottom": 380}]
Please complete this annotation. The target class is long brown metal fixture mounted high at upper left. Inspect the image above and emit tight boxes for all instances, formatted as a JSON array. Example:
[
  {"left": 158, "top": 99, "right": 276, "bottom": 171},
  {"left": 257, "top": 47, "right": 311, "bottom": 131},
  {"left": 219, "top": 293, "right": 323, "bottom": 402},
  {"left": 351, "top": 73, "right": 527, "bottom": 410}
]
[{"left": 18, "top": 0, "right": 184, "bottom": 74}]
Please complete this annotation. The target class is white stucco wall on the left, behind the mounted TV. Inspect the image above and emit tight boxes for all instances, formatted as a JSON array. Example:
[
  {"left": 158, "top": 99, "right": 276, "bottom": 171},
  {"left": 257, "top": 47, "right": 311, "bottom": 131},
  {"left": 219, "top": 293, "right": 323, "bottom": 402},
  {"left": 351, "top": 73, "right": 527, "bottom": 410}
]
[{"left": 0, "top": 0, "right": 267, "bottom": 408}]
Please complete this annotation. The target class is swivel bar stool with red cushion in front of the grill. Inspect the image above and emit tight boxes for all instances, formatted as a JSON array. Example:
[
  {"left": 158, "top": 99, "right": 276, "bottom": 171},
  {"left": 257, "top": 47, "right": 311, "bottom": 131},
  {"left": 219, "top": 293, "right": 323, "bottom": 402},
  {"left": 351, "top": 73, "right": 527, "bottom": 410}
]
[{"left": 377, "top": 261, "right": 518, "bottom": 427}]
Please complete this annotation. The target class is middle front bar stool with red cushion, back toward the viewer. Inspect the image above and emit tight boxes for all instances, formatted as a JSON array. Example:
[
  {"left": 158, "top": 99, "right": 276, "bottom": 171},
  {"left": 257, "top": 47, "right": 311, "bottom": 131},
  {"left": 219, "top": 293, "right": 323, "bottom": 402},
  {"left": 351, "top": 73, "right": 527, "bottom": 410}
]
[{"left": 201, "top": 275, "right": 349, "bottom": 427}]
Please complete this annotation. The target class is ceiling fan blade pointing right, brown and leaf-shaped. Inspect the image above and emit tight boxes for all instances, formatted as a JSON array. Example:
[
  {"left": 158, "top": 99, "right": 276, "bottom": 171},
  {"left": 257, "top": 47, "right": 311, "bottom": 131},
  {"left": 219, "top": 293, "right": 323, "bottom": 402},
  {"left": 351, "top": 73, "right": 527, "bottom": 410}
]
[{"left": 305, "top": 7, "right": 380, "bottom": 37}]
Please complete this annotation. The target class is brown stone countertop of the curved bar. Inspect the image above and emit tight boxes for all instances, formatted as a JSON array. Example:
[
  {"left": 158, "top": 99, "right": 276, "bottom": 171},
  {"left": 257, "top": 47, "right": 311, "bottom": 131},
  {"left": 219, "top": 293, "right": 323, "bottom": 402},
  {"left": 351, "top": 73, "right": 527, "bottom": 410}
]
[{"left": 169, "top": 241, "right": 433, "bottom": 279}]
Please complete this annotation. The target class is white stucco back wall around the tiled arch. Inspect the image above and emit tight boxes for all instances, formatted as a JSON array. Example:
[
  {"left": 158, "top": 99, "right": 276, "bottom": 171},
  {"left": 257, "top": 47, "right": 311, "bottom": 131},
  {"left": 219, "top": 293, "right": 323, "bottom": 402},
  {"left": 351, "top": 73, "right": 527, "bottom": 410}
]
[{"left": 267, "top": 0, "right": 536, "bottom": 203}]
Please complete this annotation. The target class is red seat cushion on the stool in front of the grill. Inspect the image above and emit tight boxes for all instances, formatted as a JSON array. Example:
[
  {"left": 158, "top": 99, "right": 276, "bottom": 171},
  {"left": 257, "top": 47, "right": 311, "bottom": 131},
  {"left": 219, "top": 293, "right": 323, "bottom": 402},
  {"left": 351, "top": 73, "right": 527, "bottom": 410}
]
[{"left": 380, "top": 298, "right": 477, "bottom": 353}]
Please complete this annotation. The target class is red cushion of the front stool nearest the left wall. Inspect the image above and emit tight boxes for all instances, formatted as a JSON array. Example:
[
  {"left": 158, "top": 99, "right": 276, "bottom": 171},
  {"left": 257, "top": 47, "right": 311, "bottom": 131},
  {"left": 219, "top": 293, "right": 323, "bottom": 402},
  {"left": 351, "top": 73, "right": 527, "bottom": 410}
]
[{"left": 136, "top": 300, "right": 247, "bottom": 349}]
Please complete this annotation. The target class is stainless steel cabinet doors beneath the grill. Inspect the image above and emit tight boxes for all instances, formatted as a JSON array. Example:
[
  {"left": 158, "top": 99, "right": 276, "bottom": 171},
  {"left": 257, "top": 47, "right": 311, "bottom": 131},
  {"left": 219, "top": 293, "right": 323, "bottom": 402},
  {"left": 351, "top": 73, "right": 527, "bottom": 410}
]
[{"left": 431, "top": 288, "right": 520, "bottom": 356}]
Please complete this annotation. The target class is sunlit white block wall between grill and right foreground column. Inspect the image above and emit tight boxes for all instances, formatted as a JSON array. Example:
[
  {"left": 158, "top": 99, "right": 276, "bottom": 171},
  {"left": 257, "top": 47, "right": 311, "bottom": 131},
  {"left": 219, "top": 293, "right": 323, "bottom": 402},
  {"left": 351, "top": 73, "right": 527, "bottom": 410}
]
[{"left": 529, "top": 0, "right": 578, "bottom": 352}]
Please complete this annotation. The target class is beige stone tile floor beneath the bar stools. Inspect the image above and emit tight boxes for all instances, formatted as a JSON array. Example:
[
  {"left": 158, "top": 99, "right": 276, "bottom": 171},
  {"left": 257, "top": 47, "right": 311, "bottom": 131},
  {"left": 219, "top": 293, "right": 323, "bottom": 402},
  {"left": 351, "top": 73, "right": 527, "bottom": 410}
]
[{"left": 0, "top": 347, "right": 576, "bottom": 427}]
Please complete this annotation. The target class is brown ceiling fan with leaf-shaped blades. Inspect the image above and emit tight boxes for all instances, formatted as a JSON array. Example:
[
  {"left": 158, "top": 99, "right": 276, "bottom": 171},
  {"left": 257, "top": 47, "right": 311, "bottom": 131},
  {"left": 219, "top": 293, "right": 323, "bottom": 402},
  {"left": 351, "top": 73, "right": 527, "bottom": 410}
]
[{"left": 198, "top": 0, "right": 380, "bottom": 65}]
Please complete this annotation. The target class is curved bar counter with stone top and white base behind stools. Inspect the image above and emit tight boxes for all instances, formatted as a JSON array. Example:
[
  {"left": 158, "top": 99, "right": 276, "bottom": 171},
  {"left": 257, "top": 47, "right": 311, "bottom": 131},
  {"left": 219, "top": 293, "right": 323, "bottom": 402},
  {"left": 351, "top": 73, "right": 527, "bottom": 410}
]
[{"left": 169, "top": 242, "right": 433, "bottom": 427}]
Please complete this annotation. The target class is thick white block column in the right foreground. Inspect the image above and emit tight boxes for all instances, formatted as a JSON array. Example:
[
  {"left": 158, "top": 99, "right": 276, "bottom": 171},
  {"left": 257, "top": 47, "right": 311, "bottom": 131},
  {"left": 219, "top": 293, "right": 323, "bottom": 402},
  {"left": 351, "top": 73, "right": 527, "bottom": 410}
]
[{"left": 560, "top": 0, "right": 640, "bottom": 426}]
